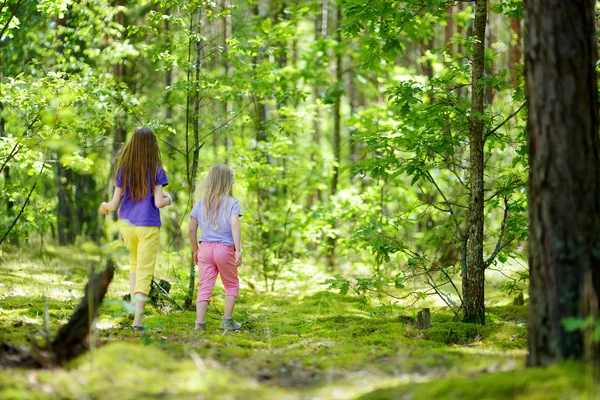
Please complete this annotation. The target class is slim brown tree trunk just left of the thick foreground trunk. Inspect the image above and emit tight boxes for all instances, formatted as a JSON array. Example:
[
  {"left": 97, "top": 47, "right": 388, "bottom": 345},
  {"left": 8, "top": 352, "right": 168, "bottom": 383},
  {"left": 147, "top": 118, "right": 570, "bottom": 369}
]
[{"left": 463, "top": 0, "right": 487, "bottom": 324}]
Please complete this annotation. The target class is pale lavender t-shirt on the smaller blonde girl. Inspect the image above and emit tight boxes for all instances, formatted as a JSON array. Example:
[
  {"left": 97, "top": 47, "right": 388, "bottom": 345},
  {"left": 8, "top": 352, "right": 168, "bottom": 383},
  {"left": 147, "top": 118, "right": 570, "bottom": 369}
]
[{"left": 190, "top": 197, "right": 242, "bottom": 246}]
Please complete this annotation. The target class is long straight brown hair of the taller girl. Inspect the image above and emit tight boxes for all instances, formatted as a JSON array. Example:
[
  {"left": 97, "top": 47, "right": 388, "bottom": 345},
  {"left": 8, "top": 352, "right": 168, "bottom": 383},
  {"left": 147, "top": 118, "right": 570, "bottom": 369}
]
[{"left": 115, "top": 128, "right": 162, "bottom": 202}]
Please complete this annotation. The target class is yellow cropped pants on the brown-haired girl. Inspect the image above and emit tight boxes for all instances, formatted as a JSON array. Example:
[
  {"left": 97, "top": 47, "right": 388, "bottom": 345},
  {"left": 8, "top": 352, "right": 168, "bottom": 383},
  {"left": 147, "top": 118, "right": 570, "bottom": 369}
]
[{"left": 120, "top": 226, "right": 160, "bottom": 296}]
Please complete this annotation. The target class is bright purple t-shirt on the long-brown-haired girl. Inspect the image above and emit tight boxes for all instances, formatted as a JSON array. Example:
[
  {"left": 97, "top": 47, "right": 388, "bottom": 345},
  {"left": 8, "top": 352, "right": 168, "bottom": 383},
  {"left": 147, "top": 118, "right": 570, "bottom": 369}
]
[{"left": 115, "top": 167, "right": 169, "bottom": 226}]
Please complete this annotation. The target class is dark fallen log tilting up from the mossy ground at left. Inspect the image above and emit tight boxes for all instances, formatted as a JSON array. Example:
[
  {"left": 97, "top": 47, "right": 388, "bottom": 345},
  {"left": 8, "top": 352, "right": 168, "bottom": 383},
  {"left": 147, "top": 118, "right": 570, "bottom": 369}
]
[{"left": 0, "top": 259, "right": 115, "bottom": 368}]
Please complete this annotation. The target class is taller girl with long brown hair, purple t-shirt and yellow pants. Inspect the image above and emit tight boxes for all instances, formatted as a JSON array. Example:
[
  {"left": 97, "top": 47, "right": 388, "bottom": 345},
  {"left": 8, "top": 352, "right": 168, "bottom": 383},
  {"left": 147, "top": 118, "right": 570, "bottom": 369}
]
[{"left": 99, "top": 128, "right": 172, "bottom": 331}]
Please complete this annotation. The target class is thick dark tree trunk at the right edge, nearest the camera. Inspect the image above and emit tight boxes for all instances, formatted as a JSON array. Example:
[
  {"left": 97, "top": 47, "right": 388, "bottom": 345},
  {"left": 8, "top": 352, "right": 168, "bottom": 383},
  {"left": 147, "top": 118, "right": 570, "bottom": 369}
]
[{"left": 525, "top": 0, "right": 600, "bottom": 366}]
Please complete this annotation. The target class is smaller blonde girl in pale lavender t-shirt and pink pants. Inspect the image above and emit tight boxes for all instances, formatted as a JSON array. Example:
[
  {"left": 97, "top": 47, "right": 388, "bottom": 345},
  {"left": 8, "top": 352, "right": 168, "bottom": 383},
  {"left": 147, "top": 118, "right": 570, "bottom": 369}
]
[{"left": 189, "top": 164, "right": 242, "bottom": 330}]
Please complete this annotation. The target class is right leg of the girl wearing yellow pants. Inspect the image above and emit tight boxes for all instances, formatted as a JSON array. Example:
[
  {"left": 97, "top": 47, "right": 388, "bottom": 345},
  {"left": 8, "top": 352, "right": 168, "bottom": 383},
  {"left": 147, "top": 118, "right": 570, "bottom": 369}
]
[{"left": 133, "top": 226, "right": 160, "bottom": 326}]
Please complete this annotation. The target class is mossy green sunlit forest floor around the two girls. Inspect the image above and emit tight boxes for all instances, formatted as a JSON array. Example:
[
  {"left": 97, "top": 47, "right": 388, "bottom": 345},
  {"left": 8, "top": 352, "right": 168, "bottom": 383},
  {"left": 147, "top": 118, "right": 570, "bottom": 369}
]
[{"left": 0, "top": 246, "right": 600, "bottom": 400}]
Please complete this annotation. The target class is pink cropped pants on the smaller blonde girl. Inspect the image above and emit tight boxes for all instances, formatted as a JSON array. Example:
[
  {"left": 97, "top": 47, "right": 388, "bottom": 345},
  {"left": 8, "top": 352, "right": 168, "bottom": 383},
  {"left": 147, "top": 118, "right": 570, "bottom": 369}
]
[{"left": 196, "top": 242, "right": 240, "bottom": 303}]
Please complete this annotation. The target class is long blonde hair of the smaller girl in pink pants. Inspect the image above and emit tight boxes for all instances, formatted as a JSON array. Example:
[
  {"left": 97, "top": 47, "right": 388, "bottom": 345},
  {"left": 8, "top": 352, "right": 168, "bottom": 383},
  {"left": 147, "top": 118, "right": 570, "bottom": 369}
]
[{"left": 198, "top": 164, "right": 233, "bottom": 229}]
